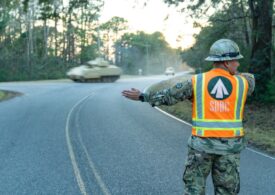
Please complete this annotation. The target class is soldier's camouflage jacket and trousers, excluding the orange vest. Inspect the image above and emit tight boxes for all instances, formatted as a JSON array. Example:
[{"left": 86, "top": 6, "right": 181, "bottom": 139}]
[{"left": 144, "top": 73, "right": 255, "bottom": 195}]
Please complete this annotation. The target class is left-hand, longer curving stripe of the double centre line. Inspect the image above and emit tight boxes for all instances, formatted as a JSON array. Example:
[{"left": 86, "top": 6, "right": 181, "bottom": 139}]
[{"left": 65, "top": 96, "right": 89, "bottom": 195}]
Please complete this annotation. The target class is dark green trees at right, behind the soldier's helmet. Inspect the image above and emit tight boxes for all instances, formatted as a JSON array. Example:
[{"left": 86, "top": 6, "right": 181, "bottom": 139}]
[{"left": 164, "top": 0, "right": 274, "bottom": 101}]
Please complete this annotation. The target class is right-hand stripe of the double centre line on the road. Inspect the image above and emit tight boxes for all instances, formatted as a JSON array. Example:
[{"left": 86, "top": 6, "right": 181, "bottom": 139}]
[{"left": 77, "top": 100, "right": 111, "bottom": 195}]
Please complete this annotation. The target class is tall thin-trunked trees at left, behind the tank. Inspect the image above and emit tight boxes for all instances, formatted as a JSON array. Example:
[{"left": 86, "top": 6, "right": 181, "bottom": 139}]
[{"left": 0, "top": 0, "right": 103, "bottom": 81}]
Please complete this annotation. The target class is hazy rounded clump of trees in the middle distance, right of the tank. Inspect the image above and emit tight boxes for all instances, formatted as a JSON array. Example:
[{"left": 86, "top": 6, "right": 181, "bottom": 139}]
[{"left": 115, "top": 32, "right": 181, "bottom": 74}]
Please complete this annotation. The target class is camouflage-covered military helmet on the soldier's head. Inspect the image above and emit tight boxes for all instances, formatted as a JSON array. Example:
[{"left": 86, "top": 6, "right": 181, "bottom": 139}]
[{"left": 205, "top": 39, "right": 243, "bottom": 62}]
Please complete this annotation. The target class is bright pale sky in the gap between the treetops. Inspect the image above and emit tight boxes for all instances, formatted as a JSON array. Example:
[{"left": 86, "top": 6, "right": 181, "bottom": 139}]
[{"left": 100, "top": 0, "right": 199, "bottom": 48}]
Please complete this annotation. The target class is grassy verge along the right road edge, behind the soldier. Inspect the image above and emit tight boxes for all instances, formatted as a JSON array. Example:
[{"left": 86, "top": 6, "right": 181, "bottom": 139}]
[{"left": 147, "top": 75, "right": 275, "bottom": 155}]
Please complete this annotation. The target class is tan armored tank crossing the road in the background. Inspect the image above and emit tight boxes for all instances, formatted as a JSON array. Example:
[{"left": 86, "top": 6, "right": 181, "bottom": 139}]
[{"left": 67, "top": 58, "right": 122, "bottom": 82}]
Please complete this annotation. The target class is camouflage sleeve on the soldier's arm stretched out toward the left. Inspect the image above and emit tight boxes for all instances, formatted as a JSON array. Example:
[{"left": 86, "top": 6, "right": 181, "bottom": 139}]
[{"left": 144, "top": 79, "right": 192, "bottom": 106}]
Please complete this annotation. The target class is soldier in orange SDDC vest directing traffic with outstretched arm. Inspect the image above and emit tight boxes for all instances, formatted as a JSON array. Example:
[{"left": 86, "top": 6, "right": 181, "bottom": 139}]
[{"left": 122, "top": 39, "right": 255, "bottom": 195}]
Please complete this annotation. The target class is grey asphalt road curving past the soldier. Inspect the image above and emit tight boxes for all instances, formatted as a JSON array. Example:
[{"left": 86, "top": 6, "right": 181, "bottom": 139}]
[{"left": 0, "top": 77, "right": 275, "bottom": 195}]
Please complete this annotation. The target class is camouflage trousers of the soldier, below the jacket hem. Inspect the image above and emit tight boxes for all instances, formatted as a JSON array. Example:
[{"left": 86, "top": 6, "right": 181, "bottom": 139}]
[{"left": 183, "top": 148, "right": 240, "bottom": 195}]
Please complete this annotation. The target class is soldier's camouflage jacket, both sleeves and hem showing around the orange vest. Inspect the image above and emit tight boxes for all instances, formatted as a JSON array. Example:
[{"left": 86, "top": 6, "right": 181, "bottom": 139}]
[{"left": 144, "top": 73, "right": 255, "bottom": 155}]
